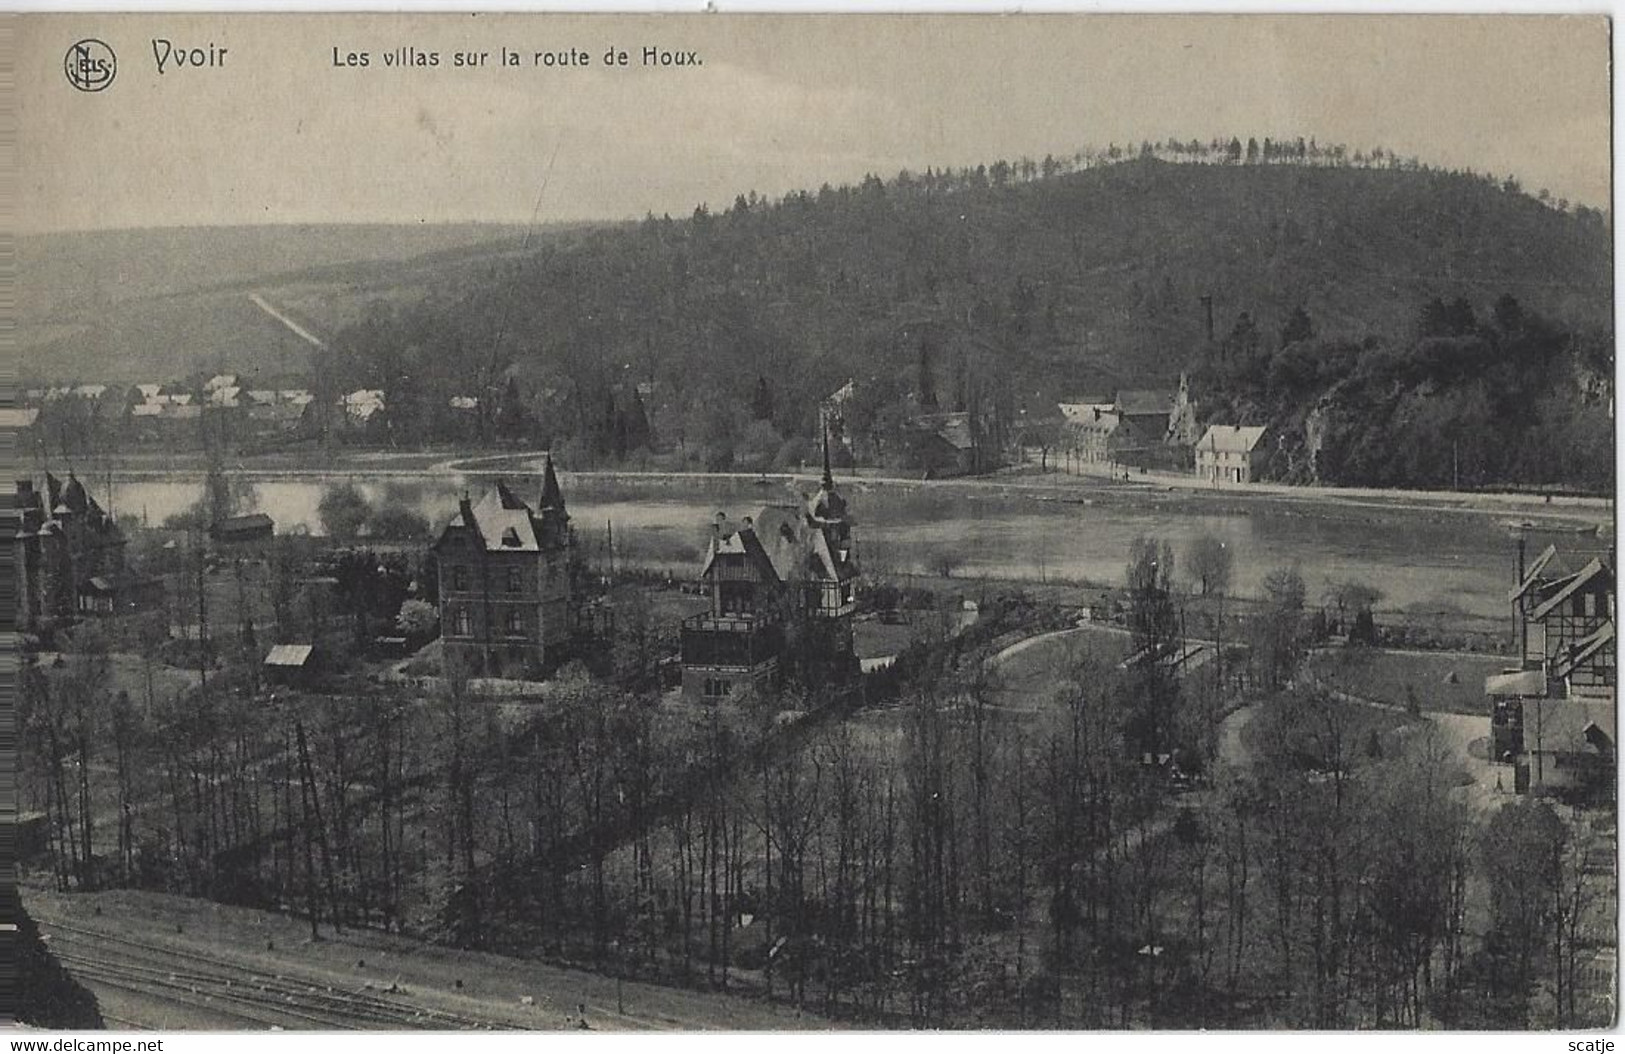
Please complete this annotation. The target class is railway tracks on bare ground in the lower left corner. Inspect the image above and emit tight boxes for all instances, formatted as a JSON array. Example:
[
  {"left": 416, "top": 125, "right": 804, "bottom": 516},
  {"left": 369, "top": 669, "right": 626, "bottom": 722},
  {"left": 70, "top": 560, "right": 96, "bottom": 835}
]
[{"left": 39, "top": 916, "right": 523, "bottom": 1030}]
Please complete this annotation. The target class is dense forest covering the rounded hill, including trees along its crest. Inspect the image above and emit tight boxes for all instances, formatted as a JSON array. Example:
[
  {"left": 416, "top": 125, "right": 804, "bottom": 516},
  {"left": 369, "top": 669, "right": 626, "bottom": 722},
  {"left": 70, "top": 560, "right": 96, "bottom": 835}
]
[{"left": 307, "top": 140, "right": 1612, "bottom": 484}]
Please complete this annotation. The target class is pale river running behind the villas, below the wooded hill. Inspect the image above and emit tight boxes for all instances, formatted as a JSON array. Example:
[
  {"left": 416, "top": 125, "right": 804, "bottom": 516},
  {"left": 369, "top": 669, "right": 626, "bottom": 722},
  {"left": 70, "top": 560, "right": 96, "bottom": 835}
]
[{"left": 111, "top": 473, "right": 1602, "bottom": 619}]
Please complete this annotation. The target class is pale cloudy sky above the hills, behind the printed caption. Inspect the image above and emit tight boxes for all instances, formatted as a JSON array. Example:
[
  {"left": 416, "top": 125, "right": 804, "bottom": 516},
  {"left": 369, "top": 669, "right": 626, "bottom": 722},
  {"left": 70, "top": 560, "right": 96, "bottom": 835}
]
[{"left": 15, "top": 13, "right": 1612, "bottom": 234}]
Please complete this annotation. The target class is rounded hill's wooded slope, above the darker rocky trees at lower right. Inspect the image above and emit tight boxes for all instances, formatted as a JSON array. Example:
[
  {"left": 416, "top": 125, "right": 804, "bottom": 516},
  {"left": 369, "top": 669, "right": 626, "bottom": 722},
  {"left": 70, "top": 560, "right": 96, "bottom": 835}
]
[{"left": 320, "top": 153, "right": 1612, "bottom": 430}]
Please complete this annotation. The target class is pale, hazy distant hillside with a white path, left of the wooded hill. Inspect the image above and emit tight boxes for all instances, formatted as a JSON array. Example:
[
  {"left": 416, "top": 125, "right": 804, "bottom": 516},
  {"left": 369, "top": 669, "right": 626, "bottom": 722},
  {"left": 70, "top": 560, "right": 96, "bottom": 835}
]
[{"left": 16, "top": 224, "right": 533, "bottom": 383}]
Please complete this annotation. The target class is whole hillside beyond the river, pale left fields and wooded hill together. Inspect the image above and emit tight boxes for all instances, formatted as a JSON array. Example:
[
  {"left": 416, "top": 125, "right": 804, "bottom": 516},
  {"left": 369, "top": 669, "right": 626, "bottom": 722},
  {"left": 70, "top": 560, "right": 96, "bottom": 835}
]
[{"left": 21, "top": 155, "right": 1612, "bottom": 487}]
